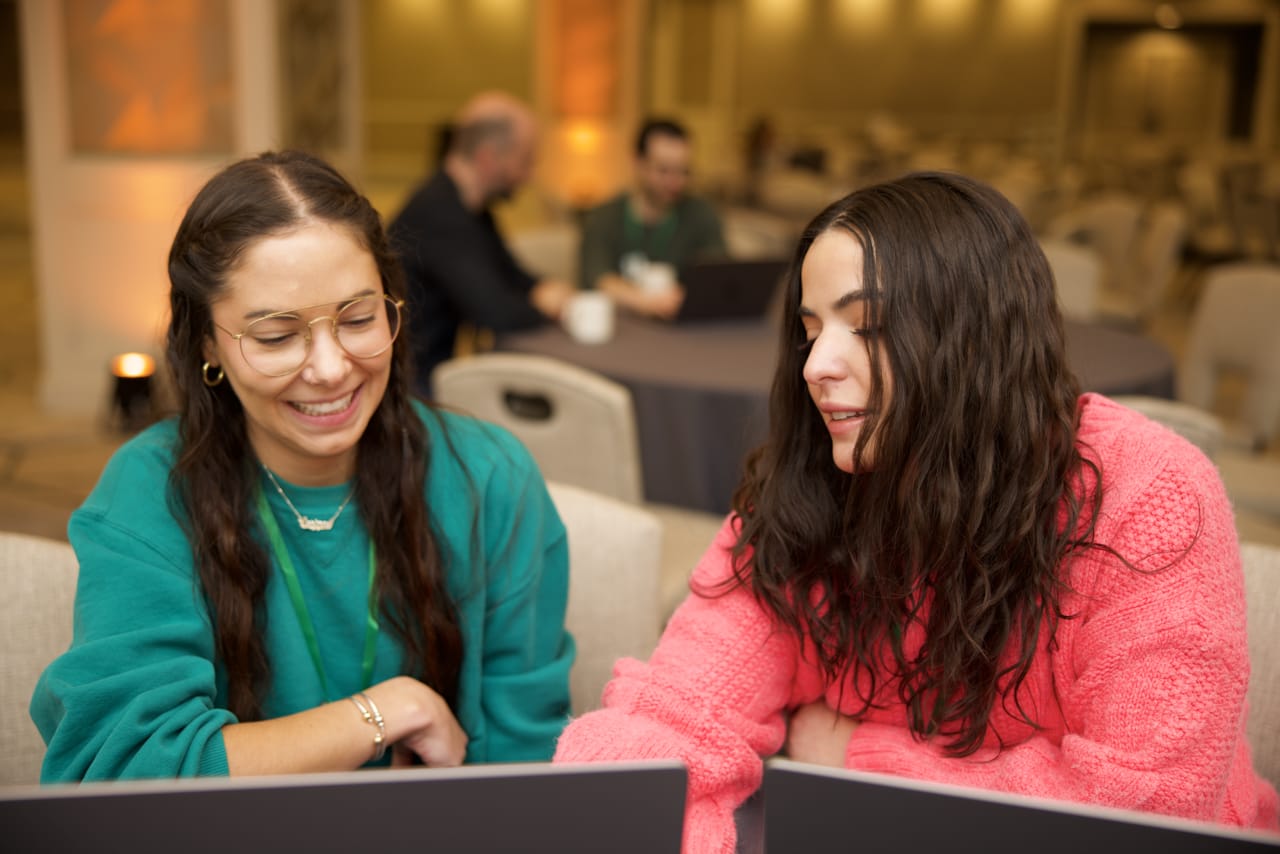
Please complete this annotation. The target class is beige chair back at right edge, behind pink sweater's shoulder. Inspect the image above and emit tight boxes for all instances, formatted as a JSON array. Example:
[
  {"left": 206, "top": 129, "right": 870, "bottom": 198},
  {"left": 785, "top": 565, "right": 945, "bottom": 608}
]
[{"left": 1240, "top": 543, "right": 1280, "bottom": 786}]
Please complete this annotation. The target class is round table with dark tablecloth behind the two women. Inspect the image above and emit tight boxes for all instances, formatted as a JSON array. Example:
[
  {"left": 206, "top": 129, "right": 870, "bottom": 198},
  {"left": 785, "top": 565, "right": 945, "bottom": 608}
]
[{"left": 497, "top": 314, "right": 1174, "bottom": 513}]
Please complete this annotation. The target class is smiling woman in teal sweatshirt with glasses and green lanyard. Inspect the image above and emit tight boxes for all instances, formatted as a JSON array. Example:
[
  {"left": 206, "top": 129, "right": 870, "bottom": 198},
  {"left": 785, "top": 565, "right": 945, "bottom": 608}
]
[{"left": 31, "top": 152, "right": 573, "bottom": 781}]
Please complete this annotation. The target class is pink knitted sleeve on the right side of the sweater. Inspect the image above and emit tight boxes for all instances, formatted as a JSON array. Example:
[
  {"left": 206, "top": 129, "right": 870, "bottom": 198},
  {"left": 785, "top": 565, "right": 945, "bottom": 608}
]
[{"left": 846, "top": 457, "right": 1275, "bottom": 825}]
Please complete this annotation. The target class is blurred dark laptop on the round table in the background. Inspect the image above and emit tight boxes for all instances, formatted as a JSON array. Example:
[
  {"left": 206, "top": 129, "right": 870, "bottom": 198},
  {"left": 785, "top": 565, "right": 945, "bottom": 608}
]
[{"left": 675, "top": 259, "right": 788, "bottom": 323}]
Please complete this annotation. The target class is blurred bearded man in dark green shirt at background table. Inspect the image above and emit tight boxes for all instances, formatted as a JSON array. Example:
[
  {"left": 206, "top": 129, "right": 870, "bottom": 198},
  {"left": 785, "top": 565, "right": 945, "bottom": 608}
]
[{"left": 580, "top": 119, "right": 726, "bottom": 318}]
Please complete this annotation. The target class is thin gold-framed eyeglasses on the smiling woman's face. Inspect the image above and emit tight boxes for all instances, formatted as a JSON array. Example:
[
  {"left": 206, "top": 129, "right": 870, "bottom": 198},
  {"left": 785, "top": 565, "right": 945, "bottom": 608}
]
[{"left": 214, "top": 294, "right": 404, "bottom": 376}]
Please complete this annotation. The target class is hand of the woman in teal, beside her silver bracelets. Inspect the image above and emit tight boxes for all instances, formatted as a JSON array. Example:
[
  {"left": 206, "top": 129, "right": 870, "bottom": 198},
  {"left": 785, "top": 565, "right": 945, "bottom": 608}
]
[{"left": 366, "top": 676, "right": 467, "bottom": 767}]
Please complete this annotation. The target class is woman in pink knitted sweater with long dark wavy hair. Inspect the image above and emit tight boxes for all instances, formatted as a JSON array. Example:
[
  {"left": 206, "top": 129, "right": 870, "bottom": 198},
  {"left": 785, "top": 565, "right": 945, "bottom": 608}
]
[{"left": 556, "top": 174, "right": 1277, "bottom": 853}]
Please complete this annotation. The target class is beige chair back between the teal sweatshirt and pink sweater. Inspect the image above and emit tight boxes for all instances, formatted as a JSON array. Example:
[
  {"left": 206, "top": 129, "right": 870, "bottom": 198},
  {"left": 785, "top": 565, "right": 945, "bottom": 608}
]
[{"left": 547, "top": 481, "right": 662, "bottom": 714}]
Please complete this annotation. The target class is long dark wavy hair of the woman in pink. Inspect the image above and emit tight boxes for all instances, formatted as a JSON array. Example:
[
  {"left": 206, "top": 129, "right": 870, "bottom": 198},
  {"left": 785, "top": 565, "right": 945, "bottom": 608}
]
[{"left": 733, "top": 173, "right": 1110, "bottom": 755}]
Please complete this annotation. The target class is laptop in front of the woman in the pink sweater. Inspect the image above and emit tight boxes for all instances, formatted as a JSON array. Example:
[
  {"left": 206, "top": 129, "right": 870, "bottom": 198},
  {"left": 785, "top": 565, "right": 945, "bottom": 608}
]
[{"left": 764, "top": 759, "right": 1280, "bottom": 854}]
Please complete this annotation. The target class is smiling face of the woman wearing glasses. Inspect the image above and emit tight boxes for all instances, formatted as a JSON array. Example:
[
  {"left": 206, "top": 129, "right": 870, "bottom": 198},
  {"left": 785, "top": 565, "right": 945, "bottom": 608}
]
[{"left": 204, "top": 222, "right": 392, "bottom": 485}]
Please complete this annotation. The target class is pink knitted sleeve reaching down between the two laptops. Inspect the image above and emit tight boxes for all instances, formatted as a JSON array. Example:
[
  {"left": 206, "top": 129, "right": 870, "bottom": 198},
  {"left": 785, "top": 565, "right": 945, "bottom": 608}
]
[{"left": 556, "top": 521, "right": 797, "bottom": 854}]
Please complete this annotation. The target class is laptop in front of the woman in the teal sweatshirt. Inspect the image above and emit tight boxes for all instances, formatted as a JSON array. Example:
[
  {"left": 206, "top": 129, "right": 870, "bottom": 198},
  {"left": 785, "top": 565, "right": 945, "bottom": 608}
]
[{"left": 0, "top": 762, "right": 686, "bottom": 854}]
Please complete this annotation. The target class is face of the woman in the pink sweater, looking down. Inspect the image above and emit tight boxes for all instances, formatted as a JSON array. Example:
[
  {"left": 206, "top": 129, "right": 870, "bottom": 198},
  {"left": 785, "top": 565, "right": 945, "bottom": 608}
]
[{"left": 800, "top": 228, "right": 891, "bottom": 474}]
